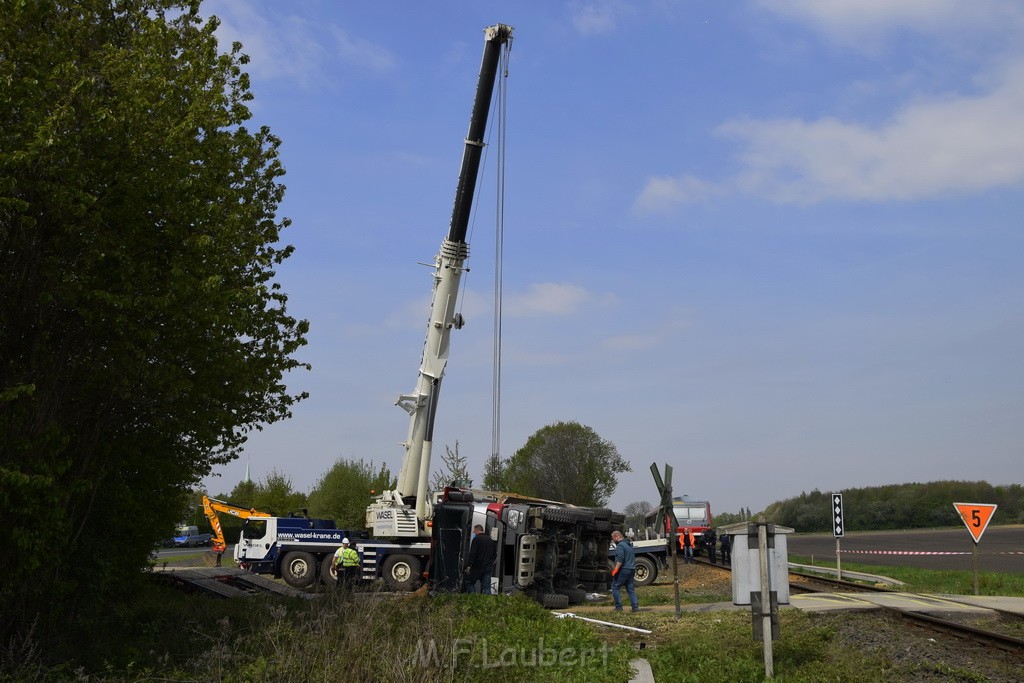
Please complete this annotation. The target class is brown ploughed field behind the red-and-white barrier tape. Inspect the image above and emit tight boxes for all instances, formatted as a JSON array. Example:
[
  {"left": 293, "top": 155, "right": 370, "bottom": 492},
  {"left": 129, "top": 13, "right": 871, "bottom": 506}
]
[{"left": 786, "top": 525, "right": 1024, "bottom": 572}]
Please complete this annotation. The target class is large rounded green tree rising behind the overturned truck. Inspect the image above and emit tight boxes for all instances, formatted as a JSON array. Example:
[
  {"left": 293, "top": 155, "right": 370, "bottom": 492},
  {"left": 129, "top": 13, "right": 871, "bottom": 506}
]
[{"left": 505, "top": 422, "right": 631, "bottom": 507}]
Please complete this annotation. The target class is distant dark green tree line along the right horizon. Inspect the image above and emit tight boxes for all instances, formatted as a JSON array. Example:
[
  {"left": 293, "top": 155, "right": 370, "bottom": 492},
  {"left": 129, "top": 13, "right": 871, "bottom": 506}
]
[{"left": 765, "top": 481, "right": 1024, "bottom": 531}]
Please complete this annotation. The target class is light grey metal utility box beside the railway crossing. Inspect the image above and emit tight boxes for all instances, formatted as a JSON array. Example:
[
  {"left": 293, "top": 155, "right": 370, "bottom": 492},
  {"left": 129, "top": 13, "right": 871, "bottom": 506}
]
[{"left": 718, "top": 522, "right": 794, "bottom": 605}]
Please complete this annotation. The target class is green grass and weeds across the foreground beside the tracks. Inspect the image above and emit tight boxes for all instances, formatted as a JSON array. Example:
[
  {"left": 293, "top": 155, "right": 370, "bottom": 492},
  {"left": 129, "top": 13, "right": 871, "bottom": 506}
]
[{"left": 8, "top": 563, "right": 1024, "bottom": 683}]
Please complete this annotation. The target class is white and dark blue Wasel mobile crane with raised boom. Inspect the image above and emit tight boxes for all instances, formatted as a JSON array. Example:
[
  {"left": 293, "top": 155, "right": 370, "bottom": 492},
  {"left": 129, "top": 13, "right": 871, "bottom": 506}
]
[{"left": 236, "top": 24, "right": 512, "bottom": 590}]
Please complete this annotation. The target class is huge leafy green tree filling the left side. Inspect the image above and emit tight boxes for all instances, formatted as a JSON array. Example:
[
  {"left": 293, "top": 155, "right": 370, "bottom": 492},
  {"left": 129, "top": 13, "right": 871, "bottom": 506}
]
[{"left": 0, "top": 0, "right": 307, "bottom": 642}]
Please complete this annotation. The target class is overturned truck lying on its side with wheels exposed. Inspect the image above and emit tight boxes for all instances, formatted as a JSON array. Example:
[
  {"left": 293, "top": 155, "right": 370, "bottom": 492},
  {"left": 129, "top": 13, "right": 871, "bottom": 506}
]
[{"left": 428, "top": 488, "right": 624, "bottom": 608}]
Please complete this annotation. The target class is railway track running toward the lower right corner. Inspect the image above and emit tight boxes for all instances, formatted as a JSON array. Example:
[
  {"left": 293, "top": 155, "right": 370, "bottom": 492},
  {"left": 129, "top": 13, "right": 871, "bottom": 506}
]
[{"left": 694, "top": 558, "right": 1024, "bottom": 656}]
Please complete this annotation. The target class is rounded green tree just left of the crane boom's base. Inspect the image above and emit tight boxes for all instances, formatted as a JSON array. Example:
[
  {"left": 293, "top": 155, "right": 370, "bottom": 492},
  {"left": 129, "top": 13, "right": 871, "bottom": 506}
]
[{"left": 309, "top": 458, "right": 395, "bottom": 529}]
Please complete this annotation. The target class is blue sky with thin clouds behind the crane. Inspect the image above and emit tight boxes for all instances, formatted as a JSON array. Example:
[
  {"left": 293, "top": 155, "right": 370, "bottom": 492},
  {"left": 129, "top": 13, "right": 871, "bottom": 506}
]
[{"left": 195, "top": 0, "right": 1024, "bottom": 520}]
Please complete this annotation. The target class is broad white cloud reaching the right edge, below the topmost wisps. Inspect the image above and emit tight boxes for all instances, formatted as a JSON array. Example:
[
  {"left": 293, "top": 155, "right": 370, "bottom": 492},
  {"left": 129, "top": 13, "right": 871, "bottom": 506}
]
[{"left": 718, "top": 61, "right": 1024, "bottom": 204}]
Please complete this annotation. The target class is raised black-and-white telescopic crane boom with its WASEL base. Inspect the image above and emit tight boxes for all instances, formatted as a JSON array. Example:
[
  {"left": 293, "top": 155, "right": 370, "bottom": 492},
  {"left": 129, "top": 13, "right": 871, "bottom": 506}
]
[{"left": 367, "top": 24, "right": 512, "bottom": 538}]
